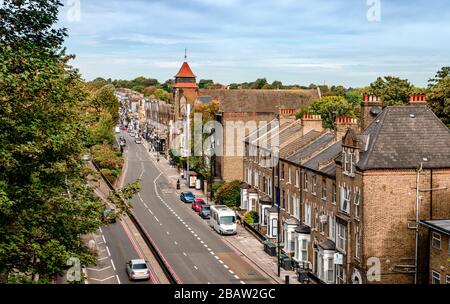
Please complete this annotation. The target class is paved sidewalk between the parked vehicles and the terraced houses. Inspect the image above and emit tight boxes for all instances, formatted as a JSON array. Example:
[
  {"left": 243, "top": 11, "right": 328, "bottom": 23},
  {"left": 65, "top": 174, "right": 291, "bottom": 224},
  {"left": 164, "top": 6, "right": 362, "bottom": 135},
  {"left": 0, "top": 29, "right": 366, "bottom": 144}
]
[{"left": 144, "top": 143, "right": 299, "bottom": 284}]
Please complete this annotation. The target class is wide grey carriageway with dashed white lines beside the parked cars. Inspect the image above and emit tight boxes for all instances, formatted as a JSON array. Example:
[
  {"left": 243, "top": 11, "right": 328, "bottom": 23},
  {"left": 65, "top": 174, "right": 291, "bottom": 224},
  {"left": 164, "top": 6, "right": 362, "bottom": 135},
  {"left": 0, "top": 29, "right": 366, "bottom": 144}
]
[{"left": 118, "top": 133, "right": 270, "bottom": 284}]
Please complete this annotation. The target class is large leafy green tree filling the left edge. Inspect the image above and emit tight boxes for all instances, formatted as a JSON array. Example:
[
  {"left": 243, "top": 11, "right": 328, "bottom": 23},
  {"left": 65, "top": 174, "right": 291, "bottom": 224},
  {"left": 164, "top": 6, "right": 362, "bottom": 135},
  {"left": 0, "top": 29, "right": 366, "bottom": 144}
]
[{"left": 0, "top": 0, "right": 137, "bottom": 283}]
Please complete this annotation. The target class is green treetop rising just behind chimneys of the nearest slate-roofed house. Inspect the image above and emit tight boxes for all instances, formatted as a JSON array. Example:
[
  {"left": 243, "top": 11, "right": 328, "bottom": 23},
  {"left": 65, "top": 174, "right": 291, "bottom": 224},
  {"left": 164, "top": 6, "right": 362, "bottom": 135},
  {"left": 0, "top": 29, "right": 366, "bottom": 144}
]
[{"left": 369, "top": 76, "right": 414, "bottom": 106}]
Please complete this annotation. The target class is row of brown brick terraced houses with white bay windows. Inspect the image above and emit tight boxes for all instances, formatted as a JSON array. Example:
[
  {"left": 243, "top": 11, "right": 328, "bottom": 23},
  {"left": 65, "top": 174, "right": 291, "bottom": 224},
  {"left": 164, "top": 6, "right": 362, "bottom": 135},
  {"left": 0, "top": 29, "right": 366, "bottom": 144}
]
[{"left": 243, "top": 95, "right": 450, "bottom": 284}]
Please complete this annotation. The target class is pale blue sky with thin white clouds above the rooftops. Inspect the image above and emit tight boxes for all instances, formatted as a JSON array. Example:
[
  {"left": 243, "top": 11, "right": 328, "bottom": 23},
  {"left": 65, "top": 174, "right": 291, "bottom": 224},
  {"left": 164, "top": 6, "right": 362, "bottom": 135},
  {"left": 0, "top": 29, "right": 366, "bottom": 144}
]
[{"left": 59, "top": 0, "right": 450, "bottom": 87}]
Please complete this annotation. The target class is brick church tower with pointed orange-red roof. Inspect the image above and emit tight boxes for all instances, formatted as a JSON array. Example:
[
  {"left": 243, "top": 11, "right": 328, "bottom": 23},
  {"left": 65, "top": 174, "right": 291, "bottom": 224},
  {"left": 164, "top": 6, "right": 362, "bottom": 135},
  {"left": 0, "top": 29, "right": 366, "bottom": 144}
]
[{"left": 173, "top": 55, "right": 198, "bottom": 120}]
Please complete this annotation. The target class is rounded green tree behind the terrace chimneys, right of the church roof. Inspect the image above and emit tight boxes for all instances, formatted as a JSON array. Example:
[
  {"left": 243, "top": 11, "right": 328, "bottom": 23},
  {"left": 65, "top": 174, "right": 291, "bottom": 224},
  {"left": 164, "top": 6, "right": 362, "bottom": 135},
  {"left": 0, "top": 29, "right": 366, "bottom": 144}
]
[{"left": 296, "top": 96, "right": 355, "bottom": 129}]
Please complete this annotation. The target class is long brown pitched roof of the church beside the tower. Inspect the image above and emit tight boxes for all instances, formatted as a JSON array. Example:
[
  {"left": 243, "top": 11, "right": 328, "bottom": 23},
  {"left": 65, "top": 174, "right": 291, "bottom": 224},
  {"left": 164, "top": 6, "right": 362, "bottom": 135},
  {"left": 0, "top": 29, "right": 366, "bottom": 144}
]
[{"left": 199, "top": 89, "right": 319, "bottom": 113}]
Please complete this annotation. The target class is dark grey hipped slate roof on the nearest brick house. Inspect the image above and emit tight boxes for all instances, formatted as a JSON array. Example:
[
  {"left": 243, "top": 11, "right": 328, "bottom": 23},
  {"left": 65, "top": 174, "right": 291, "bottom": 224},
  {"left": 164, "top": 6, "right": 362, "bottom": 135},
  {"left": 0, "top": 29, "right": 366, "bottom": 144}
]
[{"left": 357, "top": 105, "right": 450, "bottom": 170}]
